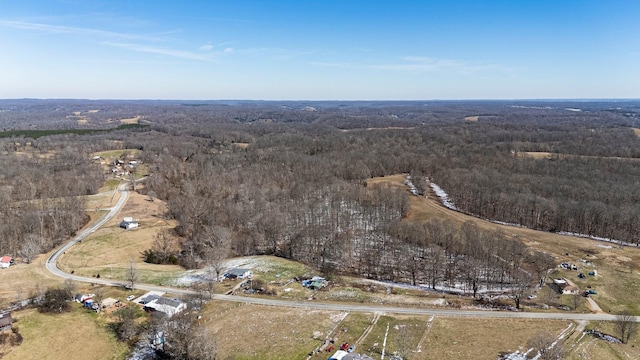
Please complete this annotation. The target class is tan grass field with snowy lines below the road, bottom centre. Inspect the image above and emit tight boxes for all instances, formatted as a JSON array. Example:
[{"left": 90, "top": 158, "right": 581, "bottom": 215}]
[{"left": 202, "top": 302, "right": 584, "bottom": 360}]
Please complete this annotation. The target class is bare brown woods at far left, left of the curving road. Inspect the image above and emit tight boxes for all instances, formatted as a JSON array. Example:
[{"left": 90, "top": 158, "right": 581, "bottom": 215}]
[{"left": 0, "top": 140, "right": 104, "bottom": 262}]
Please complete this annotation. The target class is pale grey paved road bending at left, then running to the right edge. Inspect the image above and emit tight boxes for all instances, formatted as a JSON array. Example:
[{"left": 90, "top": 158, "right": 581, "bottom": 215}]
[{"left": 45, "top": 184, "right": 640, "bottom": 322}]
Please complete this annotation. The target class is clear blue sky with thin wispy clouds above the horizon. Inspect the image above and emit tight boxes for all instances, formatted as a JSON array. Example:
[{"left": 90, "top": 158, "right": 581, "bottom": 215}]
[{"left": 0, "top": 0, "right": 640, "bottom": 100}]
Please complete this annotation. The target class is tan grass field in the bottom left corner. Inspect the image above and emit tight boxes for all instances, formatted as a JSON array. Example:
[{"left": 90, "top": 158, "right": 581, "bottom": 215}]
[{"left": 4, "top": 304, "right": 128, "bottom": 360}]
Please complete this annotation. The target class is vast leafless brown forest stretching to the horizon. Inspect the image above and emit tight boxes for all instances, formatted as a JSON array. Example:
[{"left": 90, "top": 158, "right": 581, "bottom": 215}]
[{"left": 0, "top": 100, "right": 640, "bottom": 298}]
